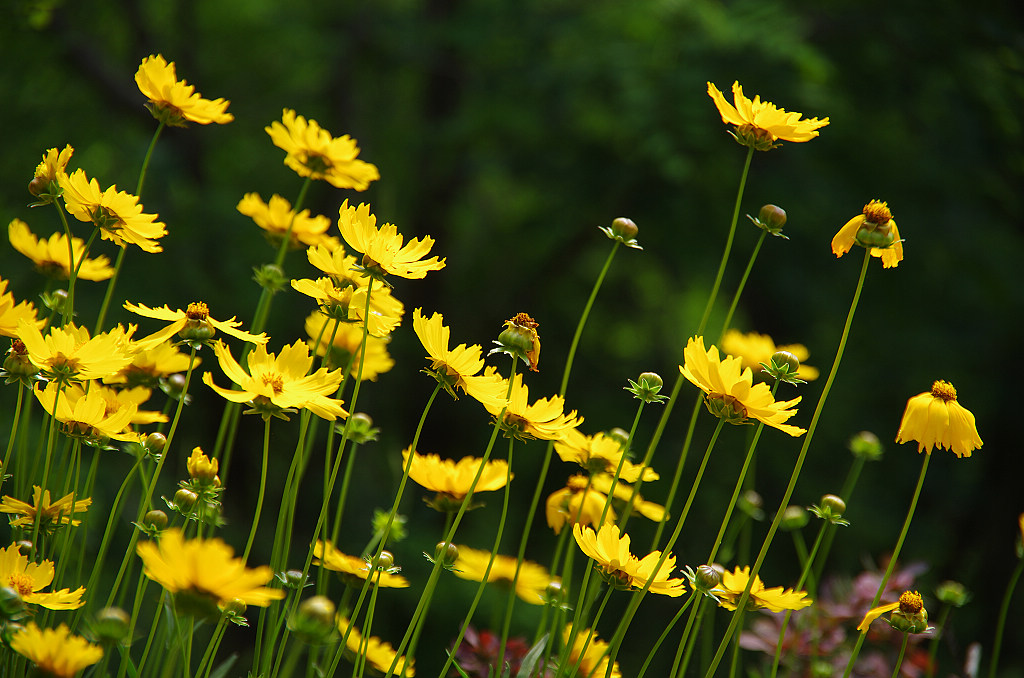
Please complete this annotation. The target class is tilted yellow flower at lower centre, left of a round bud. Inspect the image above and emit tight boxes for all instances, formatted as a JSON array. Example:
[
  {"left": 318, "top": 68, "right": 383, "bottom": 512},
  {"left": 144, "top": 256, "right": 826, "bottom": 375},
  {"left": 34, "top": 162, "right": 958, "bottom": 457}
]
[{"left": 572, "top": 524, "right": 686, "bottom": 598}]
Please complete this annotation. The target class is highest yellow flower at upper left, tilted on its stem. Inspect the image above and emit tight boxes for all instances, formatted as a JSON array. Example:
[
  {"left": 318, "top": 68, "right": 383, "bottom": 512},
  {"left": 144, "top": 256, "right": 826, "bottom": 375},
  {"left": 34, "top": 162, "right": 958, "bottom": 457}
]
[{"left": 135, "top": 54, "right": 234, "bottom": 127}]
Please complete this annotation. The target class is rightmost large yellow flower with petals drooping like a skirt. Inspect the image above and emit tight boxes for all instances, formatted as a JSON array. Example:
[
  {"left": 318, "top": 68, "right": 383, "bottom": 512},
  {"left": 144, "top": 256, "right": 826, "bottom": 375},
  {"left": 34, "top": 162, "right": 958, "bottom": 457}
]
[{"left": 896, "top": 381, "right": 981, "bottom": 458}]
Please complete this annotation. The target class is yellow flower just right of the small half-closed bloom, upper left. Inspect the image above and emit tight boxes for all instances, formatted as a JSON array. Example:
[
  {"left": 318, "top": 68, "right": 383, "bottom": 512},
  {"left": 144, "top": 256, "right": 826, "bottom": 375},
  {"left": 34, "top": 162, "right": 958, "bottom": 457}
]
[{"left": 58, "top": 169, "right": 167, "bottom": 252}]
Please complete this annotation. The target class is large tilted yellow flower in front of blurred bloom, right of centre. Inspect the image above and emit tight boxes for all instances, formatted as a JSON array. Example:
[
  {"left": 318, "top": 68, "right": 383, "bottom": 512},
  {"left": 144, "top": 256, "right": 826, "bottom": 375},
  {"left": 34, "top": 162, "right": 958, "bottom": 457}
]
[{"left": 679, "top": 337, "right": 806, "bottom": 437}]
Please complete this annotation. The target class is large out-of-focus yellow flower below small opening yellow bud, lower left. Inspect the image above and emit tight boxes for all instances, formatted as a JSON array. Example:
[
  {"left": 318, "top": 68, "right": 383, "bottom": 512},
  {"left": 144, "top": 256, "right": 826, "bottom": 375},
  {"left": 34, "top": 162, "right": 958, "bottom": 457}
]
[{"left": 135, "top": 527, "right": 285, "bottom": 607}]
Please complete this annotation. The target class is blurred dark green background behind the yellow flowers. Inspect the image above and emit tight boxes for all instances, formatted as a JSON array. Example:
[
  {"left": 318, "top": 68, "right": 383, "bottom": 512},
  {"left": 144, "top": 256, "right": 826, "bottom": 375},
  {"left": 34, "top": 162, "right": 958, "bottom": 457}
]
[{"left": 0, "top": 0, "right": 1024, "bottom": 675}]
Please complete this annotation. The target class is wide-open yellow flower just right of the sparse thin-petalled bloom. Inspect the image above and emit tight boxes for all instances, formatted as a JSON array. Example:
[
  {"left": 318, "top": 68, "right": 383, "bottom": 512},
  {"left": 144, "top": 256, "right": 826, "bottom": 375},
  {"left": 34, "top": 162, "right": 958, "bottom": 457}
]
[{"left": 203, "top": 340, "right": 348, "bottom": 421}]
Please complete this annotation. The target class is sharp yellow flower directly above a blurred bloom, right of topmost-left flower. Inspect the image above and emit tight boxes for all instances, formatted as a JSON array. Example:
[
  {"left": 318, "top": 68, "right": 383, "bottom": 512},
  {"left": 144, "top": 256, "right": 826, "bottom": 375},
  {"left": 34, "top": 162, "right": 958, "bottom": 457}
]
[{"left": 263, "top": 109, "right": 381, "bottom": 190}]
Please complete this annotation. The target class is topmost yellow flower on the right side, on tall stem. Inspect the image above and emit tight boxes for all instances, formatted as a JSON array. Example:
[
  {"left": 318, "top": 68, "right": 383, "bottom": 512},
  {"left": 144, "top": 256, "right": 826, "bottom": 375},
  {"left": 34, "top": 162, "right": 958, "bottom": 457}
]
[{"left": 708, "top": 82, "right": 828, "bottom": 151}]
